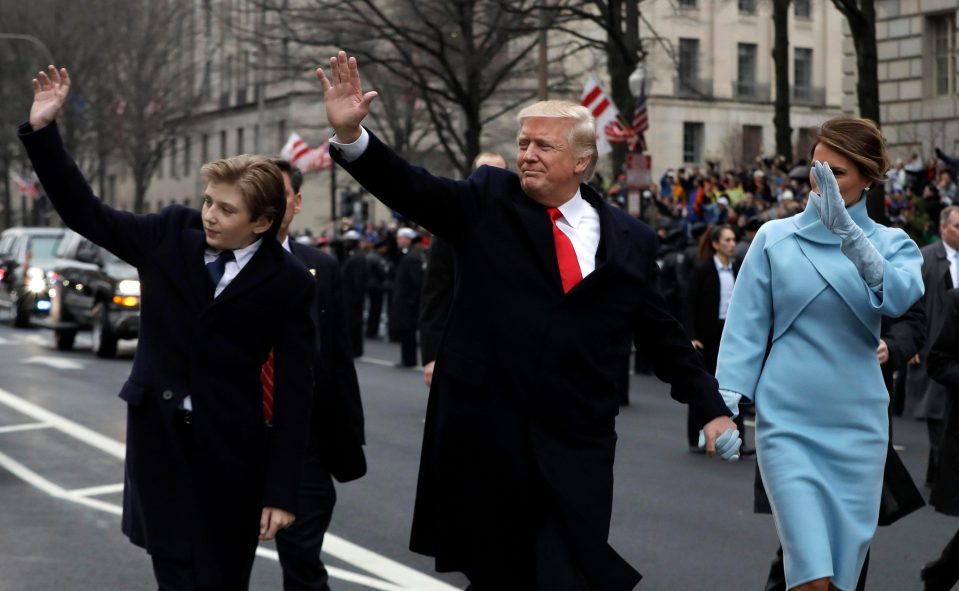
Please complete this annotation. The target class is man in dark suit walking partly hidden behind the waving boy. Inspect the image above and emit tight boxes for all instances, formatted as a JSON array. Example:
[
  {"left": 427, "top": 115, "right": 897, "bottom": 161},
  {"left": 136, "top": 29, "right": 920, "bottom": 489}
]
[{"left": 273, "top": 160, "right": 366, "bottom": 591}]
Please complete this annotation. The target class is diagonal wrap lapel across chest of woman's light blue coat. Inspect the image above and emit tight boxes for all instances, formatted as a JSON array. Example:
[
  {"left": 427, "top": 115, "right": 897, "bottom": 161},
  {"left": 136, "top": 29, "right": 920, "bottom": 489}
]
[{"left": 793, "top": 198, "right": 879, "bottom": 336}]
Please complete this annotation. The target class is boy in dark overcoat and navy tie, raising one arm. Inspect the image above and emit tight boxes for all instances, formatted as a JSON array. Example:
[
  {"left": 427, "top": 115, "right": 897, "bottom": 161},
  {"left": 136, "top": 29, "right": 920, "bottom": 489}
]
[{"left": 19, "top": 66, "right": 314, "bottom": 591}]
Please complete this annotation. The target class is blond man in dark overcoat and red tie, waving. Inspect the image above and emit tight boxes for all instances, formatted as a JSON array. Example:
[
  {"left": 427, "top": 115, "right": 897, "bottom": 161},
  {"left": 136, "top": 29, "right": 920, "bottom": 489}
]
[{"left": 317, "top": 52, "right": 739, "bottom": 591}]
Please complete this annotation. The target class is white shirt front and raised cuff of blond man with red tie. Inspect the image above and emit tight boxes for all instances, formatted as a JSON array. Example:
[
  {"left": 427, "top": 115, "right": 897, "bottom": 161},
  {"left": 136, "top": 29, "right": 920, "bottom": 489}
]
[{"left": 330, "top": 127, "right": 600, "bottom": 278}]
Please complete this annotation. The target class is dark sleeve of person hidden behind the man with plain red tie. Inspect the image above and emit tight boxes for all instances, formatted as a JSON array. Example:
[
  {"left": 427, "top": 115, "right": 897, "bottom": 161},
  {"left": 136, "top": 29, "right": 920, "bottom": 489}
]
[{"left": 420, "top": 238, "right": 454, "bottom": 365}]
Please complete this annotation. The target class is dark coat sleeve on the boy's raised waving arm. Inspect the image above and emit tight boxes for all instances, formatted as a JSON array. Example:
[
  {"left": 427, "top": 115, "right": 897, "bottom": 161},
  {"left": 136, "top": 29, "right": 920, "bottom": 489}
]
[{"left": 17, "top": 123, "right": 161, "bottom": 267}]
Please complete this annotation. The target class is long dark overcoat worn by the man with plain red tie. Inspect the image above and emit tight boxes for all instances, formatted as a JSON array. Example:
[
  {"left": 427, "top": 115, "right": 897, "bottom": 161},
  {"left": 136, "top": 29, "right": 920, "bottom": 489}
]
[{"left": 331, "top": 134, "right": 730, "bottom": 591}]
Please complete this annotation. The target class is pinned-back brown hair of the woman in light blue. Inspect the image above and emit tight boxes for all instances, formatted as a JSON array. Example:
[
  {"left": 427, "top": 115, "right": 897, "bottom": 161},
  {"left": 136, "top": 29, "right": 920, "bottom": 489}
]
[{"left": 809, "top": 117, "right": 890, "bottom": 183}]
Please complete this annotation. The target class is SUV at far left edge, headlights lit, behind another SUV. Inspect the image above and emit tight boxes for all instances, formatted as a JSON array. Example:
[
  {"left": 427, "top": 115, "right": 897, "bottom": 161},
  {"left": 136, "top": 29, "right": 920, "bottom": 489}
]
[{"left": 0, "top": 228, "right": 63, "bottom": 328}]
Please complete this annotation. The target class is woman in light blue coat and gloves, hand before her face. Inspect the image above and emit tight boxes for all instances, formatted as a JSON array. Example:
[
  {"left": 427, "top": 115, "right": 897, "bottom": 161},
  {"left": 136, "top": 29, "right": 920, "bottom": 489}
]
[{"left": 716, "top": 117, "right": 923, "bottom": 591}]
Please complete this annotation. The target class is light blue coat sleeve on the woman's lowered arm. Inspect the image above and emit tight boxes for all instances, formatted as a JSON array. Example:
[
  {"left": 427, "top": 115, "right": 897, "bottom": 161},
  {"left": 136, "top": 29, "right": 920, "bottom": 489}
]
[{"left": 716, "top": 226, "right": 773, "bottom": 400}]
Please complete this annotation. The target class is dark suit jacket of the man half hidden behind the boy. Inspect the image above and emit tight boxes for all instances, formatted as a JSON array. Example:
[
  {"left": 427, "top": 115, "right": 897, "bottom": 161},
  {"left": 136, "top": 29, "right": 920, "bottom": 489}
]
[{"left": 290, "top": 240, "right": 366, "bottom": 482}]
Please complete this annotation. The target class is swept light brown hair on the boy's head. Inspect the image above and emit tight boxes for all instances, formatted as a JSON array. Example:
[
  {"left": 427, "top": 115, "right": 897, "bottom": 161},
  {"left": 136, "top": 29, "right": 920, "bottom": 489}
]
[{"left": 200, "top": 154, "right": 286, "bottom": 236}]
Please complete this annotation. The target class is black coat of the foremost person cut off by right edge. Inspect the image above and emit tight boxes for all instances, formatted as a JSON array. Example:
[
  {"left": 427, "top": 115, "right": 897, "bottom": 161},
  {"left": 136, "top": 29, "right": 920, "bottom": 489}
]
[{"left": 928, "top": 289, "right": 959, "bottom": 517}]
